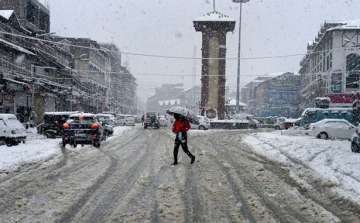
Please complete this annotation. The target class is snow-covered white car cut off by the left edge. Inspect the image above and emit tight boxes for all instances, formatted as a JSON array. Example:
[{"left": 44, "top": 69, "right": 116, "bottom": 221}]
[{"left": 0, "top": 114, "right": 26, "bottom": 146}]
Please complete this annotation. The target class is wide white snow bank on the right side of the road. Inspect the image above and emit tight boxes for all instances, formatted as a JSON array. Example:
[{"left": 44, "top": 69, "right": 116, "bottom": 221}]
[{"left": 244, "top": 132, "right": 360, "bottom": 200}]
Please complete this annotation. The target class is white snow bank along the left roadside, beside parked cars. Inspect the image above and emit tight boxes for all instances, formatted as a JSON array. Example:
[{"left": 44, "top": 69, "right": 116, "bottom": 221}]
[{"left": 0, "top": 138, "right": 61, "bottom": 171}]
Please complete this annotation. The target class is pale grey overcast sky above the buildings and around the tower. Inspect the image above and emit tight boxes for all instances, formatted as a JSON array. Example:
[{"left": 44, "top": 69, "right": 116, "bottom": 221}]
[{"left": 49, "top": 0, "right": 360, "bottom": 98}]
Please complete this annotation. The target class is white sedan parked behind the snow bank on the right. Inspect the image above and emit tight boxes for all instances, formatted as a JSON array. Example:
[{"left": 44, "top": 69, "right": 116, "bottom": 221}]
[{"left": 309, "top": 119, "right": 356, "bottom": 139}]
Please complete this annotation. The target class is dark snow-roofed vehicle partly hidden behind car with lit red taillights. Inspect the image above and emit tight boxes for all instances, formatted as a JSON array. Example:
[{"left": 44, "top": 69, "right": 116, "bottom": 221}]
[{"left": 38, "top": 112, "right": 77, "bottom": 138}]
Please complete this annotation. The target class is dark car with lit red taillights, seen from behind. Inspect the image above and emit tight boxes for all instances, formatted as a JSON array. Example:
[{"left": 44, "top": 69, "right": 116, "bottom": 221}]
[{"left": 62, "top": 113, "right": 105, "bottom": 148}]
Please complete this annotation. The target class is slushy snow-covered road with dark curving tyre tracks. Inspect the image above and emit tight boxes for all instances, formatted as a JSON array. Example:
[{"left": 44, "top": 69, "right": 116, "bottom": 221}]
[{"left": 0, "top": 127, "right": 360, "bottom": 223}]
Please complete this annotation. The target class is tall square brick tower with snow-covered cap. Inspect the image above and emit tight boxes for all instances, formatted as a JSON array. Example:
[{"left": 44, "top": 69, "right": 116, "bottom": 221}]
[{"left": 194, "top": 10, "right": 235, "bottom": 120}]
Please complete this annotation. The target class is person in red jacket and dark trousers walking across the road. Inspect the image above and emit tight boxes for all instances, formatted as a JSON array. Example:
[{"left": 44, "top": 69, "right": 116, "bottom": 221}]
[{"left": 172, "top": 114, "right": 195, "bottom": 165}]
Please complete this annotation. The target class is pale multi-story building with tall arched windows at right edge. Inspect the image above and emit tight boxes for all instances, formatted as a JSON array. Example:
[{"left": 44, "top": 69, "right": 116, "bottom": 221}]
[{"left": 299, "top": 21, "right": 360, "bottom": 107}]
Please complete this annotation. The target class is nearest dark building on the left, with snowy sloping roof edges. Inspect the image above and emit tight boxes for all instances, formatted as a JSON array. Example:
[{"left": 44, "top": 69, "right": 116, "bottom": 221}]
[{"left": 0, "top": 10, "right": 72, "bottom": 121}]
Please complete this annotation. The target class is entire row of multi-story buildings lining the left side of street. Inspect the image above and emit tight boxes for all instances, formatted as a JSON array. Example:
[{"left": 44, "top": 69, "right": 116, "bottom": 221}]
[{"left": 0, "top": 0, "right": 136, "bottom": 123}]
